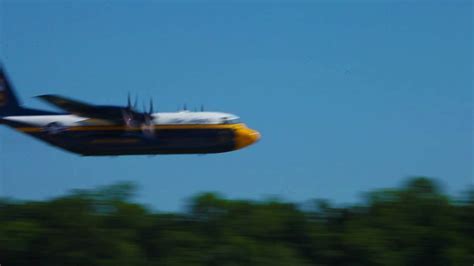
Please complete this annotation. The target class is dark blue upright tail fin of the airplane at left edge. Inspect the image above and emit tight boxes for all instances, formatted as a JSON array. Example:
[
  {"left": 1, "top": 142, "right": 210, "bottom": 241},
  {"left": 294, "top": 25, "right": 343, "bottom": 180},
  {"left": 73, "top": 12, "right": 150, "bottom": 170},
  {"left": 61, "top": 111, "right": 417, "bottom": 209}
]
[{"left": 0, "top": 65, "right": 22, "bottom": 116}]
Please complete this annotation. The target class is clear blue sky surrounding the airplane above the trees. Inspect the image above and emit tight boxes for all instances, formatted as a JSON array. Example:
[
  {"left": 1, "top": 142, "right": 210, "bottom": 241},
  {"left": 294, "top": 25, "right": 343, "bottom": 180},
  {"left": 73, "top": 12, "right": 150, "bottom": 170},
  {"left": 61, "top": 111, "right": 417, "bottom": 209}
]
[{"left": 0, "top": 0, "right": 473, "bottom": 210}]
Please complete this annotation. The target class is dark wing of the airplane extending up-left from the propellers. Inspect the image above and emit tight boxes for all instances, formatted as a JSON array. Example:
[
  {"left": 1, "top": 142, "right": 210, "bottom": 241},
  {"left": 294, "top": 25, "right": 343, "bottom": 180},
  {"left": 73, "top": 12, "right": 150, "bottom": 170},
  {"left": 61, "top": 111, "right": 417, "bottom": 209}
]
[{"left": 38, "top": 94, "right": 125, "bottom": 122}]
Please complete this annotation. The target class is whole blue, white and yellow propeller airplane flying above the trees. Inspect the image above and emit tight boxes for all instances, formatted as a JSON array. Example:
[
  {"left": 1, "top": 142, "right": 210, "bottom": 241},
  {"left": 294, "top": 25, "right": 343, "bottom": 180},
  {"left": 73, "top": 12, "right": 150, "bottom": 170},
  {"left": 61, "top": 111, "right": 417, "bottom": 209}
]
[{"left": 0, "top": 65, "right": 260, "bottom": 156}]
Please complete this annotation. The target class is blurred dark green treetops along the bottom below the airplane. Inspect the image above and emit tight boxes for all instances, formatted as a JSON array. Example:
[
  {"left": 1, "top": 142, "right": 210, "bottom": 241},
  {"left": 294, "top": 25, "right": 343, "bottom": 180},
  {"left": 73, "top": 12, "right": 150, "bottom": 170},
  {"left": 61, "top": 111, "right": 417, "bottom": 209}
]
[{"left": 0, "top": 177, "right": 474, "bottom": 266}]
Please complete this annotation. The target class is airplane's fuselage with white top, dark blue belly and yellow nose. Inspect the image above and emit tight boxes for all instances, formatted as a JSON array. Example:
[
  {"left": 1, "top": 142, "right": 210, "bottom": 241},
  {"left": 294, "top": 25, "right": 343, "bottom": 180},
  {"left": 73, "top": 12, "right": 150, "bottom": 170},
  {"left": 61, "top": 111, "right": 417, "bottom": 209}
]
[{"left": 3, "top": 111, "right": 260, "bottom": 156}]
